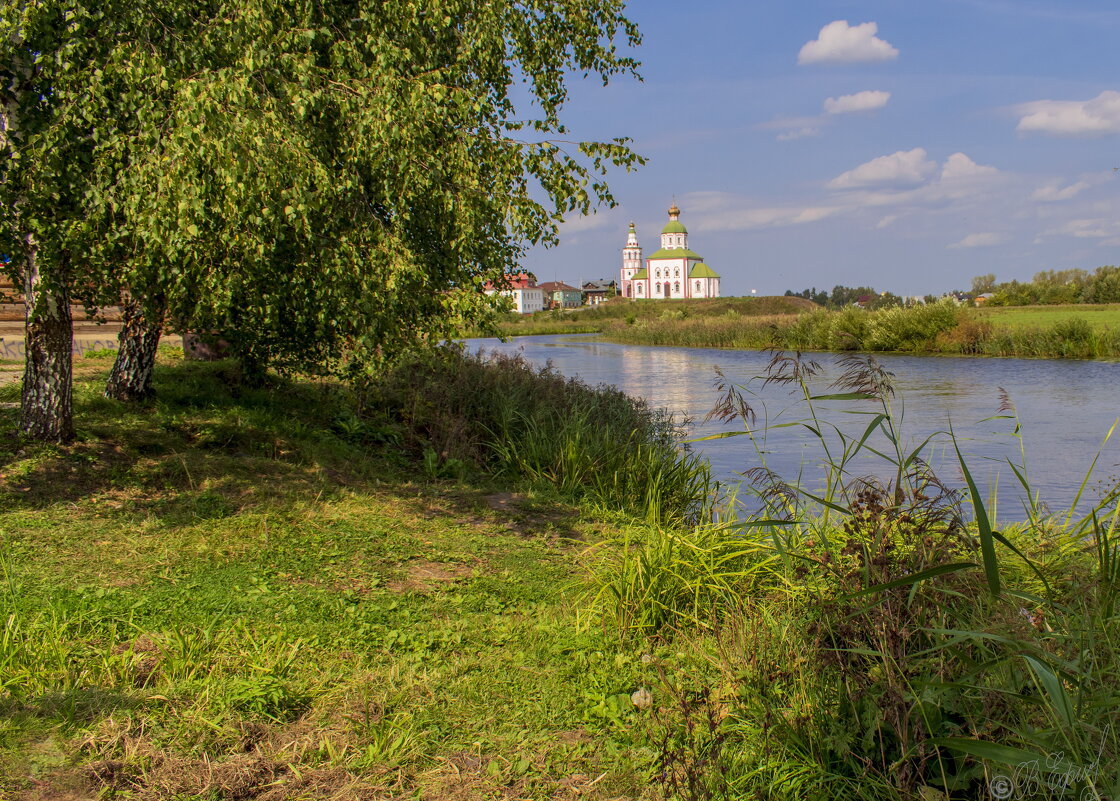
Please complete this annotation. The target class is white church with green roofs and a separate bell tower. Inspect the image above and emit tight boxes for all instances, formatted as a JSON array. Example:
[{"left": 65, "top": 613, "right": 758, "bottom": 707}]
[{"left": 619, "top": 203, "right": 719, "bottom": 300}]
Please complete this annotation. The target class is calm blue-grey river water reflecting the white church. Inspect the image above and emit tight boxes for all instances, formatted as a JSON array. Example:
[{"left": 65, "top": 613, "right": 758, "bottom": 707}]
[{"left": 468, "top": 336, "right": 1120, "bottom": 516}]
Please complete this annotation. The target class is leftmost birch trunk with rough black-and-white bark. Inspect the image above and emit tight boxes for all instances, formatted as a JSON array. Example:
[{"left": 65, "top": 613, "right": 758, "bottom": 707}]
[{"left": 19, "top": 244, "right": 74, "bottom": 443}]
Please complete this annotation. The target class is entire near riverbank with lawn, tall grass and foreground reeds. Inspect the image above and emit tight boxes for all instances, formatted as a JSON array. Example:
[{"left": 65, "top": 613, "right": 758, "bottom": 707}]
[{"left": 0, "top": 350, "right": 1120, "bottom": 800}]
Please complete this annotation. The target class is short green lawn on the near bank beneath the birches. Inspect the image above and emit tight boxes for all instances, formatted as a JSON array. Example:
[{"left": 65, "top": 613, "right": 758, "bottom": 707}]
[{"left": 0, "top": 354, "right": 707, "bottom": 799}]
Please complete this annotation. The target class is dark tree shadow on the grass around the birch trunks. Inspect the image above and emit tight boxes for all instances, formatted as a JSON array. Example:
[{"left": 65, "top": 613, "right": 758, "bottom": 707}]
[{"left": 0, "top": 360, "right": 403, "bottom": 523}]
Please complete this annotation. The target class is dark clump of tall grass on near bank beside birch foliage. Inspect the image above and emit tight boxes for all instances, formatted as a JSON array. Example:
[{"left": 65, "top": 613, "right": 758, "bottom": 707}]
[{"left": 368, "top": 347, "right": 716, "bottom": 524}]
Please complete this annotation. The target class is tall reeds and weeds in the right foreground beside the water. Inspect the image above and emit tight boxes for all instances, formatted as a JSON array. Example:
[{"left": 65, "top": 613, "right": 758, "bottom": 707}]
[{"left": 594, "top": 354, "right": 1120, "bottom": 800}]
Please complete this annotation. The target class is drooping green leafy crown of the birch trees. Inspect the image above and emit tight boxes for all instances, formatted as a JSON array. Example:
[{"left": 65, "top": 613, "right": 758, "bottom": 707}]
[{"left": 0, "top": 0, "right": 641, "bottom": 438}]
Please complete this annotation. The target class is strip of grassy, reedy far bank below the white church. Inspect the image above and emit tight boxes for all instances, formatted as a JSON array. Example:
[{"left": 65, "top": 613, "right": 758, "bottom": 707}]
[{"left": 490, "top": 298, "right": 1120, "bottom": 358}]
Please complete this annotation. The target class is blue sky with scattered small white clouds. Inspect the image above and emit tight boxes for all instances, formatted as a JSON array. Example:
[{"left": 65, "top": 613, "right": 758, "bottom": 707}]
[{"left": 524, "top": 0, "right": 1120, "bottom": 296}]
